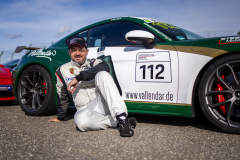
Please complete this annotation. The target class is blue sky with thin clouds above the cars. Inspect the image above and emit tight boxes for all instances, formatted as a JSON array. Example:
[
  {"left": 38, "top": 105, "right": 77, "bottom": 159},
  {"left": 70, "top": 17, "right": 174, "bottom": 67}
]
[{"left": 0, "top": 0, "right": 240, "bottom": 52}]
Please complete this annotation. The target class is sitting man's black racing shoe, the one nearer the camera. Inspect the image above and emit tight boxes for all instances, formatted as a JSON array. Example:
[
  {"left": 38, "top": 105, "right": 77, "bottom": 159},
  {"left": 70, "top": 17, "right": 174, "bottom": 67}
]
[{"left": 119, "top": 118, "right": 134, "bottom": 137}]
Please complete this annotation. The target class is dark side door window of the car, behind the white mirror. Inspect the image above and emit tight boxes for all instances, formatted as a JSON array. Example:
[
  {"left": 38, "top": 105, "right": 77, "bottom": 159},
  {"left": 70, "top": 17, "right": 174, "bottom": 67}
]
[{"left": 89, "top": 22, "right": 160, "bottom": 47}]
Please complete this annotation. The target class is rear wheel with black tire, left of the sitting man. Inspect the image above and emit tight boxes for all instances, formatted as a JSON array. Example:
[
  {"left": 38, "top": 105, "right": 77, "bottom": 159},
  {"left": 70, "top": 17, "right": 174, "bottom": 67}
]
[{"left": 17, "top": 65, "right": 56, "bottom": 116}]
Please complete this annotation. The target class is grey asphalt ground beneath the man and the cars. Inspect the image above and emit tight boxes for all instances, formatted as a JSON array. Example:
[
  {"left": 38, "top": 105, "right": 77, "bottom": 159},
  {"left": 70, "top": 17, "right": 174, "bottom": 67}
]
[{"left": 0, "top": 102, "right": 240, "bottom": 160}]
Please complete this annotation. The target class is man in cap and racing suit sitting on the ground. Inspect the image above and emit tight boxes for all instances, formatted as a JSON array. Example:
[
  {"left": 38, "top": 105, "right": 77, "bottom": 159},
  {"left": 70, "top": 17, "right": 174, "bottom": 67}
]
[{"left": 49, "top": 37, "right": 137, "bottom": 137}]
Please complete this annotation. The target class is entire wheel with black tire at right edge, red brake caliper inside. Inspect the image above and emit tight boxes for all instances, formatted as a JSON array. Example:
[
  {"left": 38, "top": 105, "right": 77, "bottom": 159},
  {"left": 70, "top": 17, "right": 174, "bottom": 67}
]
[{"left": 198, "top": 54, "right": 240, "bottom": 134}]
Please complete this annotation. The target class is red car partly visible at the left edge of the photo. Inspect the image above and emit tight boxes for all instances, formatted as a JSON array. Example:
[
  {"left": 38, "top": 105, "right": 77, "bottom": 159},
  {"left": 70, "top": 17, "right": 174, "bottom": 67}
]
[{"left": 0, "top": 59, "right": 19, "bottom": 102}]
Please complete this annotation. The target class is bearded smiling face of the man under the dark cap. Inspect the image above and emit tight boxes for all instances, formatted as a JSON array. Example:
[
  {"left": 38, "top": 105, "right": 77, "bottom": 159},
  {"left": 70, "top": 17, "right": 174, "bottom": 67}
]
[{"left": 68, "top": 45, "right": 88, "bottom": 65}]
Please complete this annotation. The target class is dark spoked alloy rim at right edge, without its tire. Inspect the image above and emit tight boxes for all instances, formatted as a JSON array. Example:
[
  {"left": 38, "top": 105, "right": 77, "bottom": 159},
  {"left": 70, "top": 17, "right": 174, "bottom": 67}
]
[{"left": 204, "top": 61, "right": 240, "bottom": 128}]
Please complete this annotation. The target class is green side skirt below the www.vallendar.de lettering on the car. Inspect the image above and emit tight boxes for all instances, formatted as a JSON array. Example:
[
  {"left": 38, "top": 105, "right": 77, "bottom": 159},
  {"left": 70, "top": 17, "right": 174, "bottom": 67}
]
[{"left": 125, "top": 101, "right": 193, "bottom": 117}]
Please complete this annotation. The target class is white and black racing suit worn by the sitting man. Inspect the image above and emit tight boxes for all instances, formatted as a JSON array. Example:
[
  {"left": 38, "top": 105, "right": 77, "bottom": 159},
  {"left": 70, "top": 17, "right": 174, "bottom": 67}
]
[{"left": 56, "top": 59, "right": 128, "bottom": 131}]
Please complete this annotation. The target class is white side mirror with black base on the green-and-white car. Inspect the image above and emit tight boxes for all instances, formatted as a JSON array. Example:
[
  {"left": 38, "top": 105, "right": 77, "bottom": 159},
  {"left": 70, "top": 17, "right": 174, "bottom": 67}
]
[{"left": 125, "top": 30, "right": 156, "bottom": 49}]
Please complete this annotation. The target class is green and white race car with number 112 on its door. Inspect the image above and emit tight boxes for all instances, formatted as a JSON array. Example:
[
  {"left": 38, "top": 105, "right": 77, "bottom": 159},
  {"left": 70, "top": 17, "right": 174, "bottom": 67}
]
[{"left": 12, "top": 17, "right": 240, "bottom": 134}]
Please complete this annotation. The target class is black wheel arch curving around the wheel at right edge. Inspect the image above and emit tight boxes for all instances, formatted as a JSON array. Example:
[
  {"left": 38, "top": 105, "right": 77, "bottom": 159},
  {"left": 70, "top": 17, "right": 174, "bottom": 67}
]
[{"left": 191, "top": 51, "right": 240, "bottom": 117}]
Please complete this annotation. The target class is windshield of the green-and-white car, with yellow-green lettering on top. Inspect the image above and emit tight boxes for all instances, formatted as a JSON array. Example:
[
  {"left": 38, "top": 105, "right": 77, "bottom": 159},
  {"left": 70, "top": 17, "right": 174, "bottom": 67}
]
[{"left": 145, "top": 19, "right": 204, "bottom": 41}]
